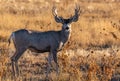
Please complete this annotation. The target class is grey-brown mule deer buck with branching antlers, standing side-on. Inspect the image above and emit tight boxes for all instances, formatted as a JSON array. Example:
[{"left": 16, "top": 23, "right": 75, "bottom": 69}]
[{"left": 8, "top": 6, "right": 80, "bottom": 76}]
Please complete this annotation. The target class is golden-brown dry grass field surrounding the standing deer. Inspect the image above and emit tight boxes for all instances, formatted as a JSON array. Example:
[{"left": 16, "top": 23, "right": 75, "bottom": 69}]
[{"left": 0, "top": 0, "right": 120, "bottom": 81}]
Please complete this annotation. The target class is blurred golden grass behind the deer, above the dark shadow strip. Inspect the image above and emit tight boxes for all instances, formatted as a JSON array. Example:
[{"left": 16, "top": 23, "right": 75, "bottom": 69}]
[{"left": 0, "top": 0, "right": 120, "bottom": 47}]
